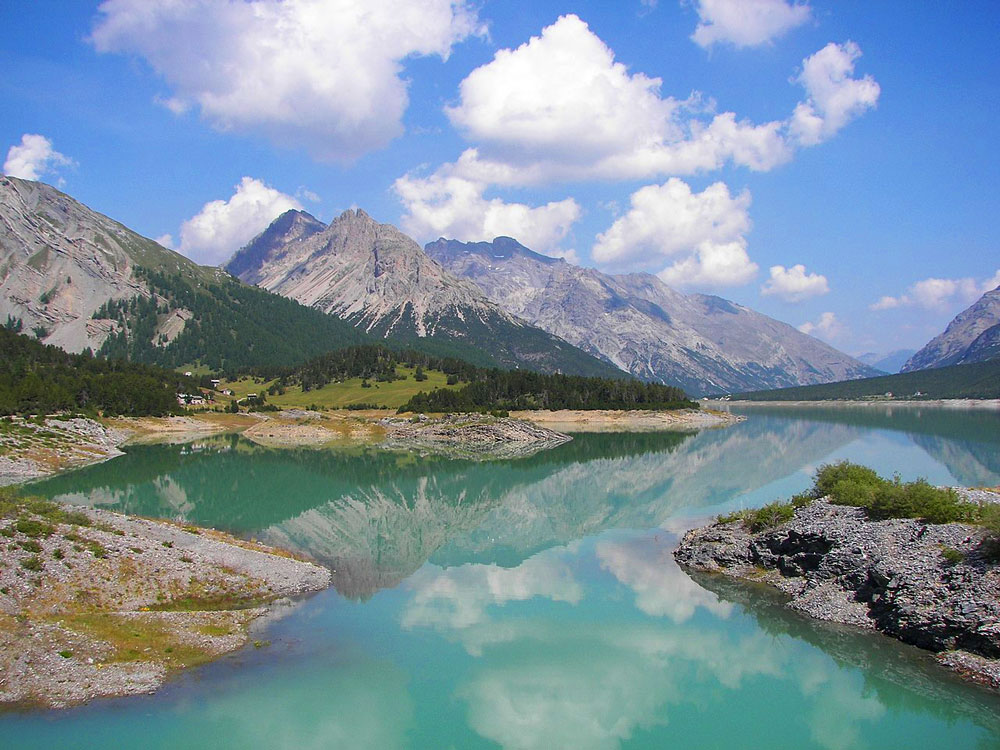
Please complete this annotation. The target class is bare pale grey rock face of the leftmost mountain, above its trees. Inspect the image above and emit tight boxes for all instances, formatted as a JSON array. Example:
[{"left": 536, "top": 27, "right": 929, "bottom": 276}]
[{"left": 0, "top": 176, "right": 214, "bottom": 352}]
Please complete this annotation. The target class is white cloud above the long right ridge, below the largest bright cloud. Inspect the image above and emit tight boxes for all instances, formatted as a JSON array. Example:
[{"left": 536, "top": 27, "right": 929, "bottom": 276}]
[{"left": 591, "top": 177, "right": 757, "bottom": 286}]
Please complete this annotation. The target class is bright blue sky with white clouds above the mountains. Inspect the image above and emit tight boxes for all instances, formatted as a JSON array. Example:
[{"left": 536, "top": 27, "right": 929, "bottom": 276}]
[{"left": 0, "top": 0, "right": 1000, "bottom": 354}]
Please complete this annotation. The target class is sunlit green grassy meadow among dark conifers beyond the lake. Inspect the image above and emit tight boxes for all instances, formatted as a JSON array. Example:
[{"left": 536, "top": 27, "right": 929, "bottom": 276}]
[{"left": 219, "top": 367, "right": 462, "bottom": 409}]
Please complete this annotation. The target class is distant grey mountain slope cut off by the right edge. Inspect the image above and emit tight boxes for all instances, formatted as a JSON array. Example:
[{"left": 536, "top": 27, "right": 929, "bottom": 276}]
[{"left": 902, "top": 286, "right": 1000, "bottom": 372}]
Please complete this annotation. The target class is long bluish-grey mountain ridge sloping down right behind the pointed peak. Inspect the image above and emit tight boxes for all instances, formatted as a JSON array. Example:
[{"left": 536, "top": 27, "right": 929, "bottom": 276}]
[{"left": 426, "top": 237, "right": 878, "bottom": 395}]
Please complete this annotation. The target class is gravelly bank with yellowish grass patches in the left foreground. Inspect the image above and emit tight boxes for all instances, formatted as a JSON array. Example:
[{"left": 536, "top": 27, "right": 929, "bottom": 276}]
[{"left": 0, "top": 500, "right": 330, "bottom": 708}]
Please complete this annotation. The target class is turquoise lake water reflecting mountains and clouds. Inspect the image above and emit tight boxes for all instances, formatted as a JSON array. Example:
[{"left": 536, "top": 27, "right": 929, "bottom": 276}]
[{"left": 0, "top": 407, "right": 1000, "bottom": 750}]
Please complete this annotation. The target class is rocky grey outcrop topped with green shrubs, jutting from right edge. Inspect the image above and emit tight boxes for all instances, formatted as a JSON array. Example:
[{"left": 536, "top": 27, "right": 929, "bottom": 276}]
[{"left": 674, "top": 462, "right": 1000, "bottom": 689}]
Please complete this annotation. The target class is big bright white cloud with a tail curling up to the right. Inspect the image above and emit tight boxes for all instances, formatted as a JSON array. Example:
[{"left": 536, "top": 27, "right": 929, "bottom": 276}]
[{"left": 406, "top": 15, "right": 877, "bottom": 194}]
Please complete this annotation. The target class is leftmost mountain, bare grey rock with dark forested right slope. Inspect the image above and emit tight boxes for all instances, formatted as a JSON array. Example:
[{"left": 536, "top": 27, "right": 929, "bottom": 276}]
[{"left": 0, "top": 176, "right": 371, "bottom": 370}]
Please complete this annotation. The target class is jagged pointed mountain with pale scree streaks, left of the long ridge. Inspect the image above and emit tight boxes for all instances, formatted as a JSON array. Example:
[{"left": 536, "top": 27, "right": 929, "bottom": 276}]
[{"left": 226, "top": 210, "right": 624, "bottom": 378}]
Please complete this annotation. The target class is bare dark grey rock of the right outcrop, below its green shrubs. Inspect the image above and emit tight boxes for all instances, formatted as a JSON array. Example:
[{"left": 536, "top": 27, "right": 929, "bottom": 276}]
[{"left": 674, "top": 490, "right": 1000, "bottom": 689}]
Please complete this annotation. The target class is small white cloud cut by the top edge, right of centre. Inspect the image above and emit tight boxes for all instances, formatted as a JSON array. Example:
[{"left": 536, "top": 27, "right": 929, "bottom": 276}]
[{"left": 691, "top": 0, "right": 812, "bottom": 48}]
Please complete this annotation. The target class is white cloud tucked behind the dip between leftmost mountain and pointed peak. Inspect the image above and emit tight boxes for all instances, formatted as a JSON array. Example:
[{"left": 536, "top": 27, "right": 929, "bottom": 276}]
[{"left": 180, "top": 177, "right": 302, "bottom": 265}]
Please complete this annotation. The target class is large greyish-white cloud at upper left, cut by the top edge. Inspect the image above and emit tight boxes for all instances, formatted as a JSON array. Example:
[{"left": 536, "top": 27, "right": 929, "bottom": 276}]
[{"left": 91, "top": 0, "right": 484, "bottom": 160}]
